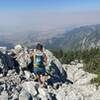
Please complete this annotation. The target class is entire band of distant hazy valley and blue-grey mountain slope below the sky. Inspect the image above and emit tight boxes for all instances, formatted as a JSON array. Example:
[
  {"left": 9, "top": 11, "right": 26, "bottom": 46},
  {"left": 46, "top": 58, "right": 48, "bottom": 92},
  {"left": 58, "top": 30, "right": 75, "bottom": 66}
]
[{"left": 0, "top": 24, "right": 100, "bottom": 50}]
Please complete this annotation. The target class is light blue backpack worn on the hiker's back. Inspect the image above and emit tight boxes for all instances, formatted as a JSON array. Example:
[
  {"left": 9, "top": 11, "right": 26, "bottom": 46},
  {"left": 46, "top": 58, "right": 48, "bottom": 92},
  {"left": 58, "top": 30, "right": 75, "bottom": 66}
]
[{"left": 33, "top": 50, "right": 44, "bottom": 67}]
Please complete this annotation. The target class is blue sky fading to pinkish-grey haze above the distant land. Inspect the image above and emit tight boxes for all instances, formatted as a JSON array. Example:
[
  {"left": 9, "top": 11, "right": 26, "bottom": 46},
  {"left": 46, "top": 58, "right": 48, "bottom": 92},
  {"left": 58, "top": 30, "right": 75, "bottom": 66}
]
[{"left": 0, "top": 0, "right": 100, "bottom": 33}]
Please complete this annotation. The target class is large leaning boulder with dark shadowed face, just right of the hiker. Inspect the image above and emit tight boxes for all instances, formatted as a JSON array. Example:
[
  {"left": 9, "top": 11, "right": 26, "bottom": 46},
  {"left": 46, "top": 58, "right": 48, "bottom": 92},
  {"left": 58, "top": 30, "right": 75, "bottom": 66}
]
[{"left": 44, "top": 50, "right": 67, "bottom": 83}]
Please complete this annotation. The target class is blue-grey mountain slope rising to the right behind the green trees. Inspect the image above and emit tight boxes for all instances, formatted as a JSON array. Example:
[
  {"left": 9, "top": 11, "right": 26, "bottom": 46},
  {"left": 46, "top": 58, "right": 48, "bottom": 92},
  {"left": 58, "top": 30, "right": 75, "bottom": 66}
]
[{"left": 45, "top": 24, "right": 100, "bottom": 50}]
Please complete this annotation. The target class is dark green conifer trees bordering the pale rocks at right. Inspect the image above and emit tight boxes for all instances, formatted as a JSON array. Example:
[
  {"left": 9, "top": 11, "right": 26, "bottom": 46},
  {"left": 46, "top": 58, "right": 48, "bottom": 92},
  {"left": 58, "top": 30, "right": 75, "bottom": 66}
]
[{"left": 52, "top": 48, "right": 100, "bottom": 85}]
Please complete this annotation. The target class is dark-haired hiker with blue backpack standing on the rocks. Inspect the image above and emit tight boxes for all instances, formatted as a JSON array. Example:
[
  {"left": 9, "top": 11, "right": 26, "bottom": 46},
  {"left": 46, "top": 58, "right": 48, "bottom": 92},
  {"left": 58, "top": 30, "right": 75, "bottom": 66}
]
[{"left": 32, "top": 43, "right": 47, "bottom": 87}]
